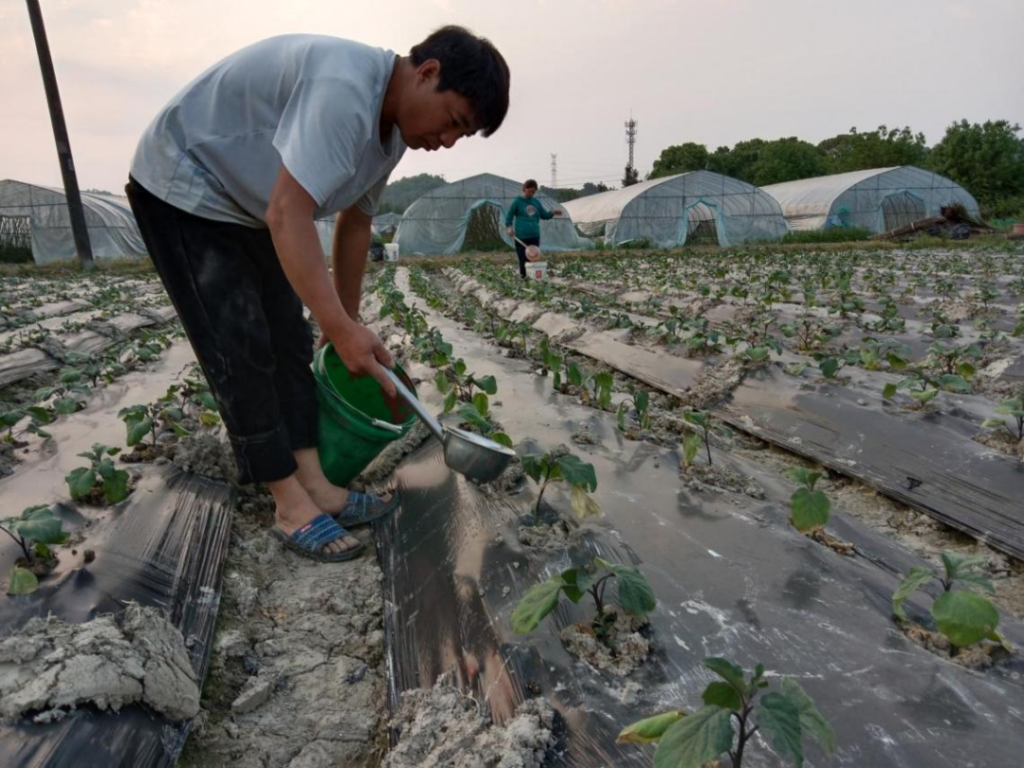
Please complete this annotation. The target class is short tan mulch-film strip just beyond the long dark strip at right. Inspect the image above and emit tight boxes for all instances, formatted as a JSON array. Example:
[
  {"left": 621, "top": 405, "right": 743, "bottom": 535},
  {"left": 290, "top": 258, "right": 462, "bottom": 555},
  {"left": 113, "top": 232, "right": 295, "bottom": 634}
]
[{"left": 565, "top": 331, "right": 703, "bottom": 397}]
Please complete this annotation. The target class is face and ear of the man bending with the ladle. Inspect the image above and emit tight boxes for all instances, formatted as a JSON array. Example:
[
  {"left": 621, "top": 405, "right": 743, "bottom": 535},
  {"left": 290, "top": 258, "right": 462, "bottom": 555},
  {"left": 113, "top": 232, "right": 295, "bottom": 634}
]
[{"left": 397, "top": 59, "right": 476, "bottom": 152}]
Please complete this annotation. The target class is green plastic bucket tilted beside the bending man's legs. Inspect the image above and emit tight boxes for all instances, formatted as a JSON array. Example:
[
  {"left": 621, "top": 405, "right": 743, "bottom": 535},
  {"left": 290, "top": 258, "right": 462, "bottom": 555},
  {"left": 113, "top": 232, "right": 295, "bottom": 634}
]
[{"left": 313, "top": 344, "right": 416, "bottom": 485}]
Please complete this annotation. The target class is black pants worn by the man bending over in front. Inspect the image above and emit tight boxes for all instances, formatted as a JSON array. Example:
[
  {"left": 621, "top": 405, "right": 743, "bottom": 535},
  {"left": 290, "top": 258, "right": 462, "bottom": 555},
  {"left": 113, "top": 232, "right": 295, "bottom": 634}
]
[{"left": 125, "top": 178, "right": 317, "bottom": 483}]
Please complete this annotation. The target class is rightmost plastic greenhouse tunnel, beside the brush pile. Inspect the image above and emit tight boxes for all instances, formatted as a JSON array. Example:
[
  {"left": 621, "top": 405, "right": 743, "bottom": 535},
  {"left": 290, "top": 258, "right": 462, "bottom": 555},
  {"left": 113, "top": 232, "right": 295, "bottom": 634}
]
[{"left": 762, "top": 165, "right": 980, "bottom": 232}]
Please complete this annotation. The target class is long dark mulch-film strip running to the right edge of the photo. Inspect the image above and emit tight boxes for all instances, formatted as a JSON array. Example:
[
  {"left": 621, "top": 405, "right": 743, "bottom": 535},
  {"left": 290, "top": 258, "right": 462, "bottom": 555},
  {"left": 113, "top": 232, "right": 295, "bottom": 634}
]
[{"left": 716, "top": 370, "right": 1024, "bottom": 558}]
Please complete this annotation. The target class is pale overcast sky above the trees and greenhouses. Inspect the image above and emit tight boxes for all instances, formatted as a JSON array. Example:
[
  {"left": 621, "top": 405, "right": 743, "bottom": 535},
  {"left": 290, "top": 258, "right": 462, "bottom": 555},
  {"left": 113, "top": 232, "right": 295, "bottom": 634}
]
[{"left": 0, "top": 0, "right": 1024, "bottom": 190}]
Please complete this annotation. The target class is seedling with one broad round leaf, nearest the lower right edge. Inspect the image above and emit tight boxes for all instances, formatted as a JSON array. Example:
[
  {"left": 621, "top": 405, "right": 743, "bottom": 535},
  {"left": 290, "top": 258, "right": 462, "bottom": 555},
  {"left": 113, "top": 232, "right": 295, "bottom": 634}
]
[{"left": 893, "top": 552, "right": 1013, "bottom": 652}]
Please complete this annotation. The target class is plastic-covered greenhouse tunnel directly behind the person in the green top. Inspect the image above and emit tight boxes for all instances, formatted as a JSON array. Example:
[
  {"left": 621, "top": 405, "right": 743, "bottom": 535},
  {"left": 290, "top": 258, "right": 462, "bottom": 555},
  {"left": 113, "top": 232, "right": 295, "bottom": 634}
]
[{"left": 393, "top": 173, "right": 592, "bottom": 255}]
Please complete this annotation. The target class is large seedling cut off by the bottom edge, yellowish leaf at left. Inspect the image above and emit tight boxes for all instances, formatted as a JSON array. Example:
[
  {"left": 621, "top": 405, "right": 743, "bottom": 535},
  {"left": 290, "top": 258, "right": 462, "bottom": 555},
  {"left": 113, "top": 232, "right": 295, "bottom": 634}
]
[{"left": 617, "top": 658, "right": 836, "bottom": 768}]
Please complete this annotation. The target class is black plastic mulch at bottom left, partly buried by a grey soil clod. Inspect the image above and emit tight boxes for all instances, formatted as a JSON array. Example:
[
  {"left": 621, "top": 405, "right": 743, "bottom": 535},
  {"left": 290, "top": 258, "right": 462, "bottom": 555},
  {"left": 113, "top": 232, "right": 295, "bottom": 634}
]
[{"left": 0, "top": 471, "right": 230, "bottom": 768}]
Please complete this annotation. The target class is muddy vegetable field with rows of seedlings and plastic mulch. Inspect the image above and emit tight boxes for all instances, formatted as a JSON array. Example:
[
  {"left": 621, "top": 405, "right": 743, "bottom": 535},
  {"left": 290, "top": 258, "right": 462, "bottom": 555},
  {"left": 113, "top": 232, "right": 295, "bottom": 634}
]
[{"left": 0, "top": 243, "right": 1024, "bottom": 767}]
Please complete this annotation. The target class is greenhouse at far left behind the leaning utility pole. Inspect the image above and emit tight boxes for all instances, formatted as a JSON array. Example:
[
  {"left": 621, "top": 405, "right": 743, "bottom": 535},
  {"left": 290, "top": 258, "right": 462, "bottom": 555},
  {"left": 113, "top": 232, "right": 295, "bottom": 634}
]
[{"left": 0, "top": 179, "right": 146, "bottom": 264}]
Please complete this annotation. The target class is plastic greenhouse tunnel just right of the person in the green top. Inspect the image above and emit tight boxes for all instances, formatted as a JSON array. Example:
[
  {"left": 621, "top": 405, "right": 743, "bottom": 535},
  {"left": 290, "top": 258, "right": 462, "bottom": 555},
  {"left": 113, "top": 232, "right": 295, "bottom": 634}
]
[{"left": 565, "top": 171, "right": 786, "bottom": 248}]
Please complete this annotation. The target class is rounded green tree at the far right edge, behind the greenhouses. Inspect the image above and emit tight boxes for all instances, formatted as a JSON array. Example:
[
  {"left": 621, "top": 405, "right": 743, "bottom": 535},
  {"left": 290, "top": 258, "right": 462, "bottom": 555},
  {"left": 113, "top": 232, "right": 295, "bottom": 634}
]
[{"left": 931, "top": 120, "right": 1024, "bottom": 206}]
